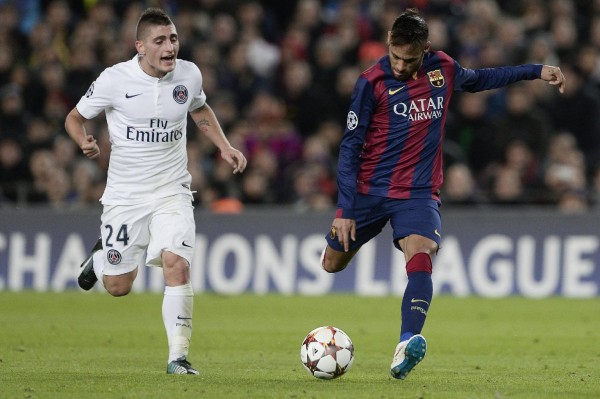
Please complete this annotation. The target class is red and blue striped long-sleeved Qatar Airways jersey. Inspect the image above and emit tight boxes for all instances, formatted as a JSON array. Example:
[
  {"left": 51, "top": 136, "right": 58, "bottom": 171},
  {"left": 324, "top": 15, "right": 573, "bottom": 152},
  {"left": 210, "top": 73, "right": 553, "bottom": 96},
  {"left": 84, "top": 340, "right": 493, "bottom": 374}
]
[{"left": 336, "top": 51, "right": 542, "bottom": 219}]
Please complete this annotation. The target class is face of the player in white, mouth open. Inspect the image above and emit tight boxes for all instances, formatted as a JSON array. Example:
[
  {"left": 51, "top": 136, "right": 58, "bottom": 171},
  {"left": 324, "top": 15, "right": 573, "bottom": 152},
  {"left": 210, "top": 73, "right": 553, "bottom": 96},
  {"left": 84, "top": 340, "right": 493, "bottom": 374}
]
[{"left": 136, "top": 25, "right": 179, "bottom": 78}]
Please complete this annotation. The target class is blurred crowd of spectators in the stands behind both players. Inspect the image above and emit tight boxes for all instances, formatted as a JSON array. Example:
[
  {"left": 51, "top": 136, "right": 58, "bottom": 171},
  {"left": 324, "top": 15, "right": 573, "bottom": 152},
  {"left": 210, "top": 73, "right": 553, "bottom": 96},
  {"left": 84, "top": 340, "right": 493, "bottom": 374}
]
[{"left": 0, "top": 0, "right": 600, "bottom": 212}]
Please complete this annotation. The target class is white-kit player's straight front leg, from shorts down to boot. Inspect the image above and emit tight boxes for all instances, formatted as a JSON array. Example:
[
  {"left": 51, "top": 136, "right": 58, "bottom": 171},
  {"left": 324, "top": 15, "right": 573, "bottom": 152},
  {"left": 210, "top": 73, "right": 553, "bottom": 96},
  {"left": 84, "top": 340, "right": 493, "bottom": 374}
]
[{"left": 147, "top": 196, "right": 199, "bottom": 374}]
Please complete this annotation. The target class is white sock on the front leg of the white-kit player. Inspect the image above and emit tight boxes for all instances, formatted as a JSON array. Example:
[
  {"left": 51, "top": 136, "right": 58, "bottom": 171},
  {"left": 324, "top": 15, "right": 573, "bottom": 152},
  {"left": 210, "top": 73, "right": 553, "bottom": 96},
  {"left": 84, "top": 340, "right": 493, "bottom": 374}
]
[{"left": 162, "top": 283, "right": 194, "bottom": 362}]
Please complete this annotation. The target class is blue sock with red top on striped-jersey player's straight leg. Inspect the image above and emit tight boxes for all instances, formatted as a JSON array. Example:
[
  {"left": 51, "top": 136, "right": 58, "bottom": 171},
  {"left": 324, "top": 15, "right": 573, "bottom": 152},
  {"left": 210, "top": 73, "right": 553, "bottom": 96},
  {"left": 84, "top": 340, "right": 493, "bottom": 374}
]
[{"left": 400, "top": 252, "right": 433, "bottom": 341}]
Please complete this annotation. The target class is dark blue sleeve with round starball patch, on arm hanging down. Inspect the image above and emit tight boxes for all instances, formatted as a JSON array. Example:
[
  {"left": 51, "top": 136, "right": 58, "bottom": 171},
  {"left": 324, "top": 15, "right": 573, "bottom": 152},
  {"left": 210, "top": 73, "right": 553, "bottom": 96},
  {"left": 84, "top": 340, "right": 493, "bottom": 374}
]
[{"left": 336, "top": 76, "right": 376, "bottom": 219}]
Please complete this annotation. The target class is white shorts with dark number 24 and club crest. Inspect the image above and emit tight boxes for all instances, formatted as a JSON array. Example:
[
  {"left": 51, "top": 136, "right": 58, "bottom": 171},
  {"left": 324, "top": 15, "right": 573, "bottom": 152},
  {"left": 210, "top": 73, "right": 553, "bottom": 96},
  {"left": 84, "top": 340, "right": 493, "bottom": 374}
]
[{"left": 101, "top": 194, "right": 196, "bottom": 276}]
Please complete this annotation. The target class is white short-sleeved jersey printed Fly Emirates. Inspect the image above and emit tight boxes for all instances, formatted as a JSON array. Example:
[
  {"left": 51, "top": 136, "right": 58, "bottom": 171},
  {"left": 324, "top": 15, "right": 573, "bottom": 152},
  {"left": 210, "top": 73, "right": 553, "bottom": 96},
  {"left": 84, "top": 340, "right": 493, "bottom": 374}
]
[{"left": 77, "top": 55, "right": 206, "bottom": 205}]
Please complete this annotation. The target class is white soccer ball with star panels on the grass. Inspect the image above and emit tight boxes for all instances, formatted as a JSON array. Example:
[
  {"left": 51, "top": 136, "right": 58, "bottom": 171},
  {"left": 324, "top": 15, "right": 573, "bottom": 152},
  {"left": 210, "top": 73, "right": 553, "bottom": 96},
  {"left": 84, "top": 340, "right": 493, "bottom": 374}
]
[{"left": 300, "top": 326, "right": 354, "bottom": 380}]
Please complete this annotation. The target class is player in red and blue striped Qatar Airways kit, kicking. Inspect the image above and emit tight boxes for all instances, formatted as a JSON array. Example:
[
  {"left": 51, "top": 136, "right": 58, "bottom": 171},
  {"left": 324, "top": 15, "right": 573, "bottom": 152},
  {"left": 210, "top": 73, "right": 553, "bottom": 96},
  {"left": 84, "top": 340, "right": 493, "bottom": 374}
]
[{"left": 321, "top": 9, "right": 565, "bottom": 379}]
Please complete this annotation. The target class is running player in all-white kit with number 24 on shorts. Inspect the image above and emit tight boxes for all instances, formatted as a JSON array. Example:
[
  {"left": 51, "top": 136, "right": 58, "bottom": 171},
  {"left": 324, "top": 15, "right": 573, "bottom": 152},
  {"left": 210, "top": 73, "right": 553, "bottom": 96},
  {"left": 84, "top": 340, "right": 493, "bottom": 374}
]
[{"left": 65, "top": 8, "right": 247, "bottom": 374}]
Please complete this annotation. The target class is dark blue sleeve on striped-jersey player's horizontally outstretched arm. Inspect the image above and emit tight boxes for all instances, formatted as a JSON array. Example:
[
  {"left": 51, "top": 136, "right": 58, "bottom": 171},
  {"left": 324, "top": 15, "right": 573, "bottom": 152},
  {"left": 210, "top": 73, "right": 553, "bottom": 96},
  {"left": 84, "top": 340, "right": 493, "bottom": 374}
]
[{"left": 454, "top": 61, "right": 542, "bottom": 93}]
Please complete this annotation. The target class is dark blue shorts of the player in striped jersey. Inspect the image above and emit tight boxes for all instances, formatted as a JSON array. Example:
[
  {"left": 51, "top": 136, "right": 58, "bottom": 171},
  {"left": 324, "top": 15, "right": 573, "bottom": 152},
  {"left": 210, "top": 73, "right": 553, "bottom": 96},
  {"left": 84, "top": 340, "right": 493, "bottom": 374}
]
[{"left": 325, "top": 194, "right": 442, "bottom": 251}]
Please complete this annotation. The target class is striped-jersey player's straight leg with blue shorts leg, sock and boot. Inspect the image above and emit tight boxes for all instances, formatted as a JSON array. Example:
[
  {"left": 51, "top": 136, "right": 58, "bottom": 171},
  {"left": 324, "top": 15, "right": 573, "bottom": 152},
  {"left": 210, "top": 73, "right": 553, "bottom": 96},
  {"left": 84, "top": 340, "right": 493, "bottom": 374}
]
[{"left": 390, "top": 200, "right": 441, "bottom": 379}]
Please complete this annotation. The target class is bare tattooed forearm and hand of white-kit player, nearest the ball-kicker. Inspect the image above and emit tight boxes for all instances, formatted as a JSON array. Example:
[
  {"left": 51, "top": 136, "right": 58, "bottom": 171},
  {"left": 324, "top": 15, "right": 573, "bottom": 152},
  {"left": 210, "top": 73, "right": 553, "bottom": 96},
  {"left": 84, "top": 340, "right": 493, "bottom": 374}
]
[{"left": 190, "top": 103, "right": 247, "bottom": 173}]
